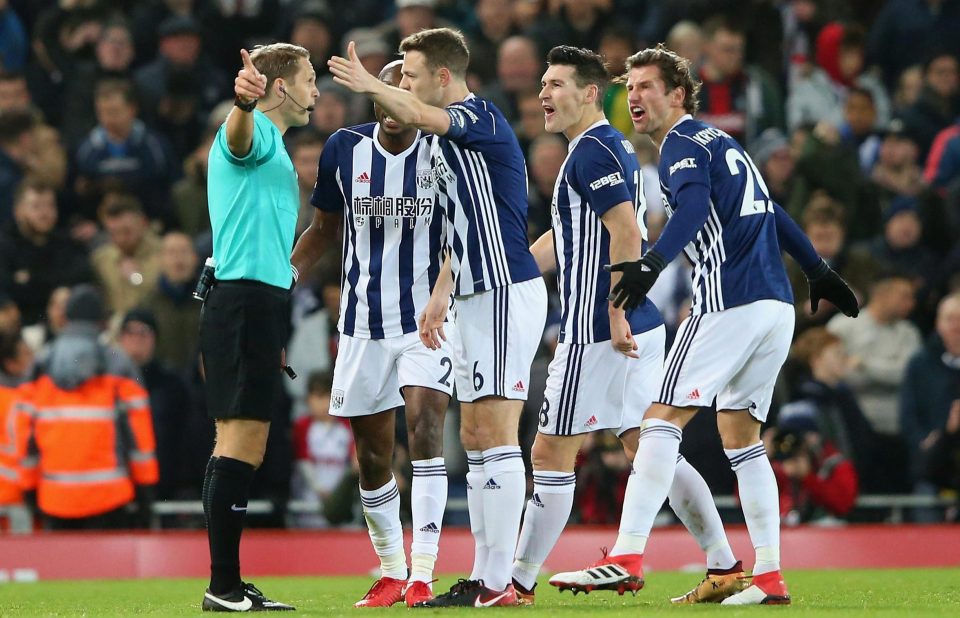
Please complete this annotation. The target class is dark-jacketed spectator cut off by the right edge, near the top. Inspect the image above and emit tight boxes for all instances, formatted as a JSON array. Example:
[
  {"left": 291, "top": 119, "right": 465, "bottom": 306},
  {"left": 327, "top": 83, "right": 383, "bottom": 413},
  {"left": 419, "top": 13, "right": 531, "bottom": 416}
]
[{"left": 900, "top": 50, "right": 960, "bottom": 160}]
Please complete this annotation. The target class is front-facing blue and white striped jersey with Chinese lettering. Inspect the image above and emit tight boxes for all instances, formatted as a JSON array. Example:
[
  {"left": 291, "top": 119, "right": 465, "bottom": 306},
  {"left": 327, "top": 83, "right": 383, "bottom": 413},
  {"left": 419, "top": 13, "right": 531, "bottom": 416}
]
[{"left": 310, "top": 123, "right": 443, "bottom": 339}]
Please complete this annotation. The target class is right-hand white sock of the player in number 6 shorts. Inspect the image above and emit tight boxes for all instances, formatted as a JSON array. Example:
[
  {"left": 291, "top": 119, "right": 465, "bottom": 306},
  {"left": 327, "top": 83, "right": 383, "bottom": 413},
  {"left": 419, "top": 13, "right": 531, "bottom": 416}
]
[{"left": 480, "top": 446, "right": 527, "bottom": 591}]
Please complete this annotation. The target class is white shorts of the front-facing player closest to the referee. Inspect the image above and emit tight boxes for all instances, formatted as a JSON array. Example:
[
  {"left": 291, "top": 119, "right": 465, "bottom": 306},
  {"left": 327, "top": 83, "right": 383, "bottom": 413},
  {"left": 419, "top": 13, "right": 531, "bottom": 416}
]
[{"left": 330, "top": 323, "right": 457, "bottom": 417}]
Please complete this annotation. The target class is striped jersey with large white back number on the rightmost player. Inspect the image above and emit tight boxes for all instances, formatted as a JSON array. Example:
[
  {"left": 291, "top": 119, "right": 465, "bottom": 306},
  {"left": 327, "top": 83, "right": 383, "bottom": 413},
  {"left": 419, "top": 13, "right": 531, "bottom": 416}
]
[{"left": 660, "top": 115, "right": 793, "bottom": 315}]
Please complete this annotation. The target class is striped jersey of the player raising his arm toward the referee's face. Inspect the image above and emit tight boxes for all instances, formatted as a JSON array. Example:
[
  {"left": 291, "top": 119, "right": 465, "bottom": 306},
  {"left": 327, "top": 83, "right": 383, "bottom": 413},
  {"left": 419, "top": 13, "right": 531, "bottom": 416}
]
[{"left": 432, "top": 94, "right": 540, "bottom": 296}]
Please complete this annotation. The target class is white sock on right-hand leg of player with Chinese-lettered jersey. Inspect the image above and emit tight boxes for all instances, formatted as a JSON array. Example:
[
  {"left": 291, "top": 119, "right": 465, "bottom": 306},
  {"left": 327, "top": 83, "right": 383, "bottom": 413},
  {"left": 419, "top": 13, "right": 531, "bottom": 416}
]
[{"left": 410, "top": 457, "right": 447, "bottom": 583}]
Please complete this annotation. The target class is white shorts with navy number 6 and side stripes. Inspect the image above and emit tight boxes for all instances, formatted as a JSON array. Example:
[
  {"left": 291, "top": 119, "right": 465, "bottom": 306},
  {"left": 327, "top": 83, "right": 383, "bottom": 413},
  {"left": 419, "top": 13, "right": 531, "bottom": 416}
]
[{"left": 454, "top": 277, "right": 547, "bottom": 403}]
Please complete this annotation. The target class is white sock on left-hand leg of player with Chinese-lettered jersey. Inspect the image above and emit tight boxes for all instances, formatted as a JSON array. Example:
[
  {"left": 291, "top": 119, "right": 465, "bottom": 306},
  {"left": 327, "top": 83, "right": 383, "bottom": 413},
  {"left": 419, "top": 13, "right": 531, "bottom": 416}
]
[{"left": 360, "top": 476, "right": 407, "bottom": 579}]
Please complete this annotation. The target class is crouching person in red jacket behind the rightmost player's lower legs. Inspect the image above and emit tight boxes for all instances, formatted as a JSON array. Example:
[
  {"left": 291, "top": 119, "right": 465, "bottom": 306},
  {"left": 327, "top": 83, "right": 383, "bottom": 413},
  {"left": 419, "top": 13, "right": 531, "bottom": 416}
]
[{"left": 771, "top": 415, "right": 858, "bottom": 526}]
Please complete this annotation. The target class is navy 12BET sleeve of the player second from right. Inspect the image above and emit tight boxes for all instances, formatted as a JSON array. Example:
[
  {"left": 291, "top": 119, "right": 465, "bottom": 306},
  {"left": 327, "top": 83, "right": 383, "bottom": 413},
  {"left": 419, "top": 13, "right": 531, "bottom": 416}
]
[{"left": 573, "top": 137, "right": 634, "bottom": 217}]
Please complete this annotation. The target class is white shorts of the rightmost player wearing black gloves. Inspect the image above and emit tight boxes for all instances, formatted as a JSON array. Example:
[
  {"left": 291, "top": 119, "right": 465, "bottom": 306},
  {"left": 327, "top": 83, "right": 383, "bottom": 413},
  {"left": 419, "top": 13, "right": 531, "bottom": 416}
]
[{"left": 656, "top": 300, "right": 794, "bottom": 422}]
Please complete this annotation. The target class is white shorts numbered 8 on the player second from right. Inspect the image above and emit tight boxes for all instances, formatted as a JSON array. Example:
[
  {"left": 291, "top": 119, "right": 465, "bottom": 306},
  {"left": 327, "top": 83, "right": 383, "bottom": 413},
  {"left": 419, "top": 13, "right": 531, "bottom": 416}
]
[{"left": 539, "top": 326, "right": 666, "bottom": 436}]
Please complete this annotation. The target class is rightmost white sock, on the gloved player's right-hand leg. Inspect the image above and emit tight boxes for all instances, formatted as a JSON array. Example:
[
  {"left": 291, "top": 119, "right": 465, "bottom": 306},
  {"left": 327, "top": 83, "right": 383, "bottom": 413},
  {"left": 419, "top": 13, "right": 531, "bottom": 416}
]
[{"left": 723, "top": 442, "right": 780, "bottom": 575}]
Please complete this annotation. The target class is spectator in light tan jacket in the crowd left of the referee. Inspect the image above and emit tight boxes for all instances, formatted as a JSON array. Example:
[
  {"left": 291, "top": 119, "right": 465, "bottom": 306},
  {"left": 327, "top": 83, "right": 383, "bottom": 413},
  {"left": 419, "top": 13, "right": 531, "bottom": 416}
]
[{"left": 90, "top": 194, "right": 160, "bottom": 319}]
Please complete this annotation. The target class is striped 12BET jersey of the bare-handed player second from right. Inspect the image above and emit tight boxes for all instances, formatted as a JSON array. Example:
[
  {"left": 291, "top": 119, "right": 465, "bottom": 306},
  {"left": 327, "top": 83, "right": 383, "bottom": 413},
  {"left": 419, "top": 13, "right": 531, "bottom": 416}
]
[{"left": 551, "top": 120, "right": 663, "bottom": 343}]
